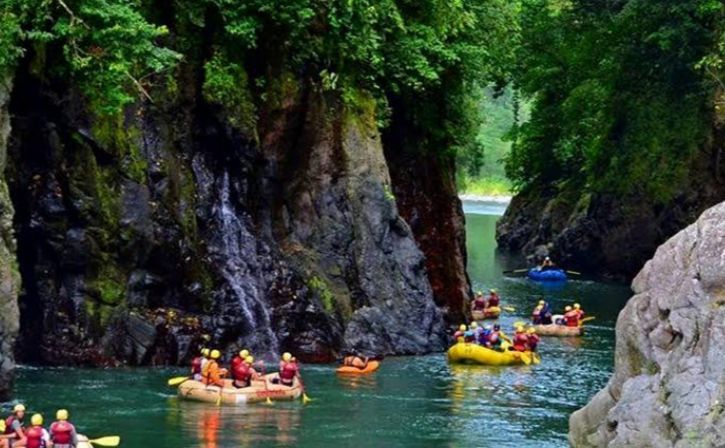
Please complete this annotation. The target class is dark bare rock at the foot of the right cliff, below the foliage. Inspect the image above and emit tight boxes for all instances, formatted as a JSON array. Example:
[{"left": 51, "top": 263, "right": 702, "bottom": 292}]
[{"left": 496, "top": 163, "right": 725, "bottom": 280}]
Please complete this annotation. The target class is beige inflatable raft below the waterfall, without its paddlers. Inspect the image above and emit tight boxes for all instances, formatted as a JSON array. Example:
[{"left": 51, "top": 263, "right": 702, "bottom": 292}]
[{"left": 179, "top": 373, "right": 303, "bottom": 406}]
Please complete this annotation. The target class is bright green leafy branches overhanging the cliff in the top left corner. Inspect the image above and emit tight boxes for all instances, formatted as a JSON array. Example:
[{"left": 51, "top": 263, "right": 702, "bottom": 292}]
[{"left": 0, "top": 0, "right": 179, "bottom": 114}]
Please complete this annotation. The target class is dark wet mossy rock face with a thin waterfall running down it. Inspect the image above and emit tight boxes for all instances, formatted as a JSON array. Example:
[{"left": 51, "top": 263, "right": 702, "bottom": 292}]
[{"left": 4, "top": 54, "right": 445, "bottom": 365}]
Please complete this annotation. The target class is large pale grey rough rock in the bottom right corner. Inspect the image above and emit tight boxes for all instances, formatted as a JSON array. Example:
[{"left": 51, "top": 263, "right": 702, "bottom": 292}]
[{"left": 569, "top": 203, "right": 725, "bottom": 448}]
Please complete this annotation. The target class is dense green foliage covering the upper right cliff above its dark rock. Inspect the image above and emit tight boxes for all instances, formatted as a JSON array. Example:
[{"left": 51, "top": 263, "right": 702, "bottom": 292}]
[{"left": 506, "top": 0, "right": 723, "bottom": 201}]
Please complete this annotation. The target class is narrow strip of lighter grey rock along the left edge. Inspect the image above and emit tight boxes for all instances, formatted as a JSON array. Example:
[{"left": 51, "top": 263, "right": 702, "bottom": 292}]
[{"left": 0, "top": 78, "right": 19, "bottom": 400}]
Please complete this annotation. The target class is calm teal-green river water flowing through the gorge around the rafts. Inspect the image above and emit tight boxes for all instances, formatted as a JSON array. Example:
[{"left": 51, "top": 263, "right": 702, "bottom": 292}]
[{"left": 3, "top": 204, "right": 629, "bottom": 448}]
